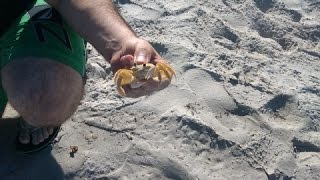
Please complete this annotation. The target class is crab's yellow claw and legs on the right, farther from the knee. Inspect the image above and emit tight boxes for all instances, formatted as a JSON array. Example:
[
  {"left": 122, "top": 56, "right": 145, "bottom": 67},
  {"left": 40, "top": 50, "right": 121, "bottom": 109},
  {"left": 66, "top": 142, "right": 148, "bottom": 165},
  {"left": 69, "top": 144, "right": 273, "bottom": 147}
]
[{"left": 154, "top": 62, "right": 176, "bottom": 82}]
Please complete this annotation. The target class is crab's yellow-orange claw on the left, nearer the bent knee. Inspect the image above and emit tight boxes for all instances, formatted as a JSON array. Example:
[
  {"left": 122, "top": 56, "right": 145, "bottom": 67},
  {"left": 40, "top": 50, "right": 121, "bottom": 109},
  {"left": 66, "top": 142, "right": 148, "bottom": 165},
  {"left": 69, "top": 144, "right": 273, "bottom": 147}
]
[{"left": 113, "top": 69, "right": 134, "bottom": 96}]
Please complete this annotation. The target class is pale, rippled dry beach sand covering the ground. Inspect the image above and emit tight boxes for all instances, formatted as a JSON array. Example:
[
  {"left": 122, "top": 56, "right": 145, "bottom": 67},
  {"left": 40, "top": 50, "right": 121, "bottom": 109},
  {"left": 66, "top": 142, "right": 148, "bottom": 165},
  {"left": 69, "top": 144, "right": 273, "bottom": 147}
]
[{"left": 0, "top": 0, "right": 320, "bottom": 180}]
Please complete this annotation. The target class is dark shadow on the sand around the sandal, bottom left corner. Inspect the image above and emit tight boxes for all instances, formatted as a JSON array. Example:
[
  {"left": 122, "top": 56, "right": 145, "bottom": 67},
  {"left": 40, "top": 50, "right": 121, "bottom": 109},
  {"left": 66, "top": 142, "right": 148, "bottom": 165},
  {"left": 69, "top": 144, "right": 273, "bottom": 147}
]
[{"left": 0, "top": 118, "right": 64, "bottom": 180}]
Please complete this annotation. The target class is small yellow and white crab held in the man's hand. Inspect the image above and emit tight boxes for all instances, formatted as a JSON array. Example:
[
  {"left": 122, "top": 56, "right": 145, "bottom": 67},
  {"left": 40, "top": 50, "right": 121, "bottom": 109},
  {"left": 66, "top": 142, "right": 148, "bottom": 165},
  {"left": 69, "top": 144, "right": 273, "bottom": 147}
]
[{"left": 114, "top": 62, "right": 175, "bottom": 96}]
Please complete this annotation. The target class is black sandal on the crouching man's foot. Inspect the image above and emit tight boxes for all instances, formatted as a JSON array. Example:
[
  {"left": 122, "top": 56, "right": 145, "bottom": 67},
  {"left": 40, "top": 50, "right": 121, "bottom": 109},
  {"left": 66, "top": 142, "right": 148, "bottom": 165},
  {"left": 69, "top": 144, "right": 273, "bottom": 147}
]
[{"left": 16, "top": 120, "right": 60, "bottom": 154}]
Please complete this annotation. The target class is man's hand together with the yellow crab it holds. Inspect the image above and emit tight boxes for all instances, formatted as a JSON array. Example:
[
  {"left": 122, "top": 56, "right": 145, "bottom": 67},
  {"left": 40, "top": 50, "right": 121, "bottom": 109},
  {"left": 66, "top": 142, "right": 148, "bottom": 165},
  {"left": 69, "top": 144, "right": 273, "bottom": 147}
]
[{"left": 110, "top": 38, "right": 175, "bottom": 97}]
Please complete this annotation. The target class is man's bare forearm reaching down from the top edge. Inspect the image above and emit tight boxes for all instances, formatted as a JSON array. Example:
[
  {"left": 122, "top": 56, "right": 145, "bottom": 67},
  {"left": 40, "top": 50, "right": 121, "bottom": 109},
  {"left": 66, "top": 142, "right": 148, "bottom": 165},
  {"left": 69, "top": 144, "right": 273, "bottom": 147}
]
[{"left": 47, "top": 0, "right": 135, "bottom": 61}]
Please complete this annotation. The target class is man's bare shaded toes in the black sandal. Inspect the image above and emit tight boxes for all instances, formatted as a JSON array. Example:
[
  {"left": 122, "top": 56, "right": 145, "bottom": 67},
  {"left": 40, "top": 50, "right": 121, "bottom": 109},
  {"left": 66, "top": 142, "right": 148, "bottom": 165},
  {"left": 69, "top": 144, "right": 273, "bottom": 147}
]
[{"left": 19, "top": 122, "right": 54, "bottom": 145}]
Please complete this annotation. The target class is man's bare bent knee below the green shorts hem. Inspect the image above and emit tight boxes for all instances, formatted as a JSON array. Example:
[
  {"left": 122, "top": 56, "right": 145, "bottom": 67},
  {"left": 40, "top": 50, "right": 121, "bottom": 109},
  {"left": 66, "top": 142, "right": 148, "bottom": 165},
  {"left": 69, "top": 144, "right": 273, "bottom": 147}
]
[{"left": 1, "top": 58, "right": 83, "bottom": 126}]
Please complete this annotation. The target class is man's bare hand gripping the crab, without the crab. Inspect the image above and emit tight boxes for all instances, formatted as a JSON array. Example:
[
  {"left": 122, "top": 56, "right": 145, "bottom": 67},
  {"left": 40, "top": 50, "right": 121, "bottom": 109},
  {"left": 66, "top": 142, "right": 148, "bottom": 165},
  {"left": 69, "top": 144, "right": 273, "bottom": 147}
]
[{"left": 110, "top": 38, "right": 175, "bottom": 97}]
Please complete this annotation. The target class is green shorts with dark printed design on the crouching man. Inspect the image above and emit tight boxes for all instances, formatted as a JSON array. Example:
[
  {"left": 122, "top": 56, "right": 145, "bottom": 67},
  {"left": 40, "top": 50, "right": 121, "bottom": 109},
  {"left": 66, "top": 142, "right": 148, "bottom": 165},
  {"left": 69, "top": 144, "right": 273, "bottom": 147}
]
[{"left": 0, "top": 0, "right": 86, "bottom": 112}]
